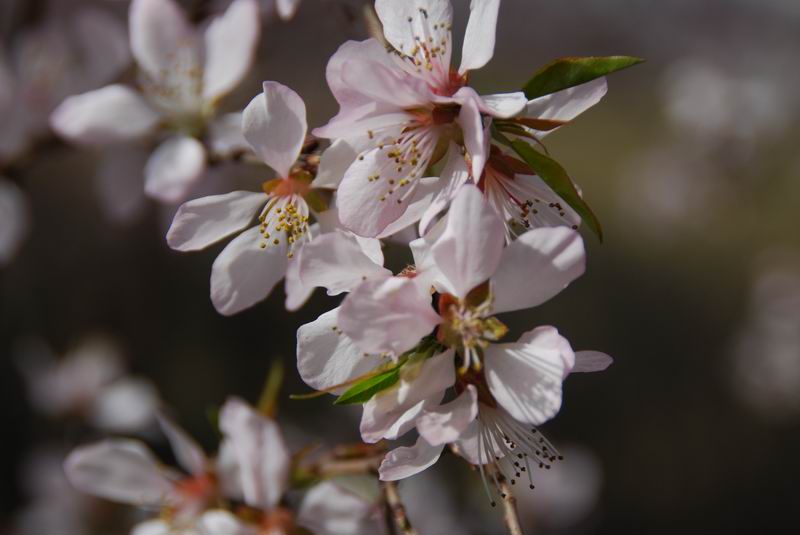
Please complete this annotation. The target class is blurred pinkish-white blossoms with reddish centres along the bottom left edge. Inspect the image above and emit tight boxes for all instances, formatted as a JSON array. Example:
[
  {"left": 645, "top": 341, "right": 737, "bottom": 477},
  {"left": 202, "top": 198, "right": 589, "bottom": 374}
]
[{"left": 64, "top": 398, "right": 381, "bottom": 535}]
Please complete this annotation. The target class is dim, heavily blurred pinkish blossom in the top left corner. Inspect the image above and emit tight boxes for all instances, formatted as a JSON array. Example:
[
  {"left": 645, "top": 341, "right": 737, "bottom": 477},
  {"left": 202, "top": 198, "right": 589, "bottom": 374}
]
[{"left": 0, "top": 8, "right": 130, "bottom": 162}]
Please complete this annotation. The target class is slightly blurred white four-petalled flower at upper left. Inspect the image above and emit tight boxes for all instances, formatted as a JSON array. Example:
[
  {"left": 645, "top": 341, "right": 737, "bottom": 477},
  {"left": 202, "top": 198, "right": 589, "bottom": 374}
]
[{"left": 51, "top": 0, "right": 259, "bottom": 202}]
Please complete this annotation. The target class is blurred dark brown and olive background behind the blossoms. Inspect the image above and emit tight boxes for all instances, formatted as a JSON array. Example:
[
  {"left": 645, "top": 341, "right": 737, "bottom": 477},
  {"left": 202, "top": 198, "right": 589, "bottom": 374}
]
[{"left": 0, "top": 0, "right": 800, "bottom": 535}]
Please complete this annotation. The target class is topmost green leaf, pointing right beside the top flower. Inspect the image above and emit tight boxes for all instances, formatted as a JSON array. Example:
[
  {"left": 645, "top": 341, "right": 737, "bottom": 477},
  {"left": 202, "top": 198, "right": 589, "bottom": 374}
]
[{"left": 522, "top": 56, "right": 644, "bottom": 100}]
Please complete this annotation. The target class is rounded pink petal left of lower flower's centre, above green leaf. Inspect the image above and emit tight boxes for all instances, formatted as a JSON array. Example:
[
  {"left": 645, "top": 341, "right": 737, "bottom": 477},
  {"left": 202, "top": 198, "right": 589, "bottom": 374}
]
[{"left": 339, "top": 277, "right": 440, "bottom": 355}]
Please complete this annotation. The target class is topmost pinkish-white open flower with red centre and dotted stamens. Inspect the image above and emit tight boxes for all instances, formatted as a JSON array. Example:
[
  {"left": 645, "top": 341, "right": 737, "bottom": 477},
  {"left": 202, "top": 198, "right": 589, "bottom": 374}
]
[{"left": 314, "top": 0, "right": 527, "bottom": 236}]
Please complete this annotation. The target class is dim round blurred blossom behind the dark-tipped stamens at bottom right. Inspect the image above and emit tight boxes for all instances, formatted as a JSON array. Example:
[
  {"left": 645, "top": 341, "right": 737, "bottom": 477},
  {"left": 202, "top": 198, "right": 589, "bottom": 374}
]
[{"left": 515, "top": 445, "right": 603, "bottom": 533}]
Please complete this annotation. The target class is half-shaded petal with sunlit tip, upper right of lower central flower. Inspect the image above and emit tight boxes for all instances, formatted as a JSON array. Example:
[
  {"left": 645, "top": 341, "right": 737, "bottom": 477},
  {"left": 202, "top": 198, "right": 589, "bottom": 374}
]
[{"left": 492, "top": 227, "right": 586, "bottom": 313}]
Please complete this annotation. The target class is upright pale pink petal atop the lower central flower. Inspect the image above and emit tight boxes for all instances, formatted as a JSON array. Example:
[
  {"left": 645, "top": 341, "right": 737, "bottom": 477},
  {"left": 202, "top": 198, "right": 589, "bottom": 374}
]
[{"left": 431, "top": 185, "right": 505, "bottom": 298}]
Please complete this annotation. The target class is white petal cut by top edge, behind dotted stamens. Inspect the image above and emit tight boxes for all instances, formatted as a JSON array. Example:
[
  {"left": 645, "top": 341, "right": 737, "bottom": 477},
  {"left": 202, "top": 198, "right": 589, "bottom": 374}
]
[{"left": 375, "top": 0, "right": 453, "bottom": 59}]
